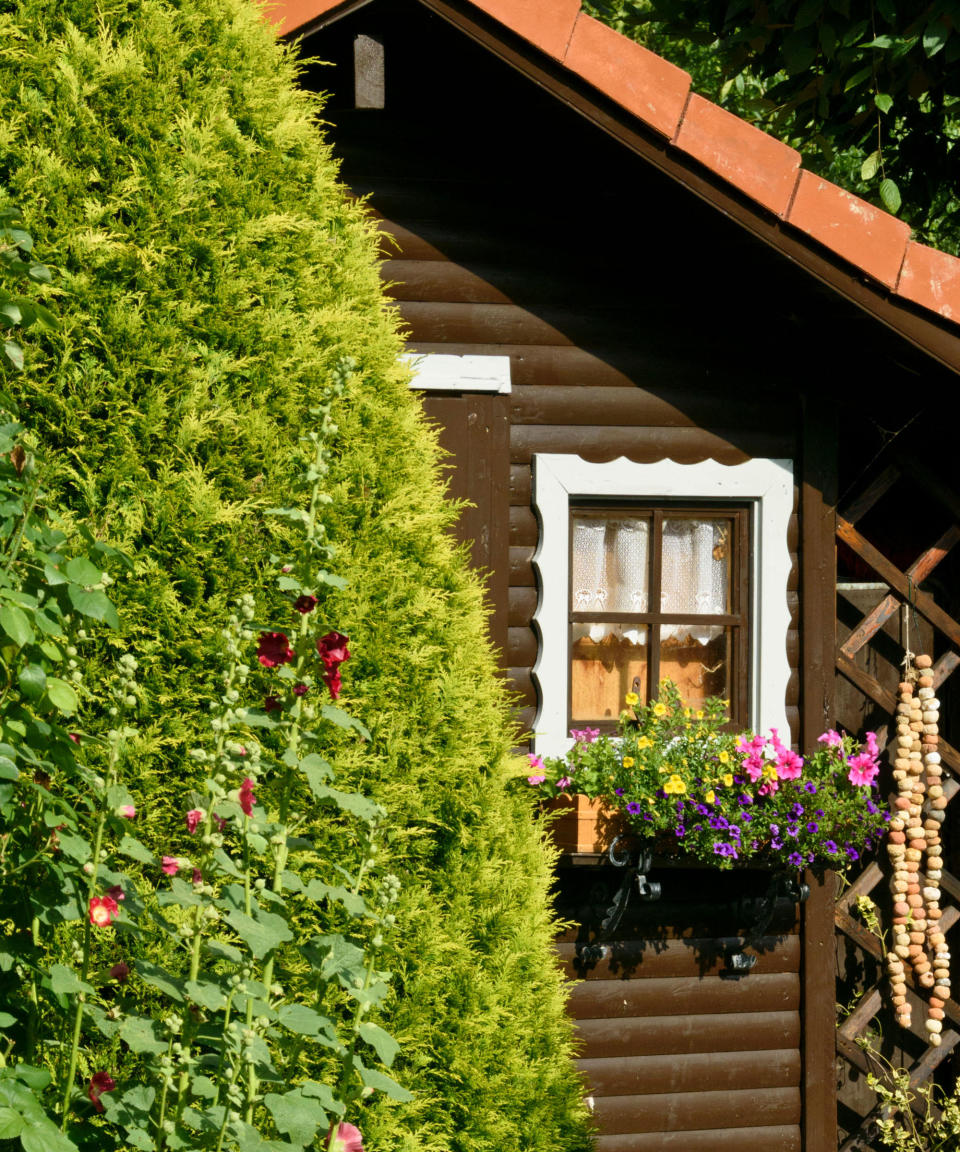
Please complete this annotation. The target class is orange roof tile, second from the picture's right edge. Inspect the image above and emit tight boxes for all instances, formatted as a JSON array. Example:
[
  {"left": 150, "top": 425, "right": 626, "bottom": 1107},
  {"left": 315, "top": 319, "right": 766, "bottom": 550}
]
[{"left": 787, "top": 172, "right": 910, "bottom": 288}]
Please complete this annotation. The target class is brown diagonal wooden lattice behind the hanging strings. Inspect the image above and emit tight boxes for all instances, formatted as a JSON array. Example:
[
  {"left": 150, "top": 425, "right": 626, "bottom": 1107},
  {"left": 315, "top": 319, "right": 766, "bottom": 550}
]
[{"left": 834, "top": 458, "right": 960, "bottom": 1152}]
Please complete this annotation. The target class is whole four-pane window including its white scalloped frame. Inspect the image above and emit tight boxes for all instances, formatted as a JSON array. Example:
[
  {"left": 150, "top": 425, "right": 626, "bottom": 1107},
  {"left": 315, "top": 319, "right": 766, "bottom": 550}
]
[{"left": 534, "top": 454, "right": 793, "bottom": 755}]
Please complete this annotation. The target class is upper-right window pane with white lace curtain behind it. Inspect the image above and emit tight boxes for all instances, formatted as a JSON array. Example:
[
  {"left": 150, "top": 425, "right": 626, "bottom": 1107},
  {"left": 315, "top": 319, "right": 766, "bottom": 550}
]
[{"left": 660, "top": 516, "right": 733, "bottom": 615}]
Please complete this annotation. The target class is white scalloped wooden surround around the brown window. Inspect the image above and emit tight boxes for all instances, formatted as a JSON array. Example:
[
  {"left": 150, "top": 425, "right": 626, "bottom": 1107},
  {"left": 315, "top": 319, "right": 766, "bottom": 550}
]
[{"left": 532, "top": 453, "right": 793, "bottom": 756}]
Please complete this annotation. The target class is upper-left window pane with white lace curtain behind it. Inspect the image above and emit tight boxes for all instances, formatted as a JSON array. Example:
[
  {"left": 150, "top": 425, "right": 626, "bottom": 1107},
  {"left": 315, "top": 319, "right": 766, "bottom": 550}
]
[{"left": 570, "top": 513, "right": 650, "bottom": 612}]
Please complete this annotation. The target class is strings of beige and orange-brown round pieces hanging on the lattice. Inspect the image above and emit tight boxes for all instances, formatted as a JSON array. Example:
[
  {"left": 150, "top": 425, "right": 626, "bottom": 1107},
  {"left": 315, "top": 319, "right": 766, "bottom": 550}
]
[{"left": 887, "top": 653, "right": 950, "bottom": 1046}]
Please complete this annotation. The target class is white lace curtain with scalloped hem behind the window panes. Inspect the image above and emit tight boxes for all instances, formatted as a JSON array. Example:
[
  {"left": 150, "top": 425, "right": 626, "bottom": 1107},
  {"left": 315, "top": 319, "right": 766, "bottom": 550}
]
[{"left": 570, "top": 517, "right": 730, "bottom": 644}]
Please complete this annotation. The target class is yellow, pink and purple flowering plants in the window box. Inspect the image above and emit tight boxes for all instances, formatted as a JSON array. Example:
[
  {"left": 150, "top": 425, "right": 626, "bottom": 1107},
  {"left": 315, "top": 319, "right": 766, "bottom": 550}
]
[{"left": 528, "top": 681, "right": 890, "bottom": 869}]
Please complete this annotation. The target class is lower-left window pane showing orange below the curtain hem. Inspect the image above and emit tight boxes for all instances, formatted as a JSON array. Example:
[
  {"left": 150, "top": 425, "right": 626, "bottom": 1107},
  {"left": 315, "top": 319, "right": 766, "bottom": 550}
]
[{"left": 570, "top": 624, "right": 647, "bottom": 725}]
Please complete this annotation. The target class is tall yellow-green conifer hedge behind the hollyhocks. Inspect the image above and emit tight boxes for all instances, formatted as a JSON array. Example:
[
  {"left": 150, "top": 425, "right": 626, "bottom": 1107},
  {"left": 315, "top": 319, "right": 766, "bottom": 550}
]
[{"left": 0, "top": 0, "right": 589, "bottom": 1152}]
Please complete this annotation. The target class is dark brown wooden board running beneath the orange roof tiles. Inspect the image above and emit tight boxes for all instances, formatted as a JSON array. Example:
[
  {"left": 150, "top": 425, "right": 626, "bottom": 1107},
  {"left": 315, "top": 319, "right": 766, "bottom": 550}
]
[{"left": 286, "top": 0, "right": 960, "bottom": 372}]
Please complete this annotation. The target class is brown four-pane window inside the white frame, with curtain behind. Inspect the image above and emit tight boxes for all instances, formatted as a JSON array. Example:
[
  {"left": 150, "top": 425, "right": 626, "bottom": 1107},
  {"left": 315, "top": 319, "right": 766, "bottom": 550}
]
[{"left": 568, "top": 502, "right": 750, "bottom": 730}]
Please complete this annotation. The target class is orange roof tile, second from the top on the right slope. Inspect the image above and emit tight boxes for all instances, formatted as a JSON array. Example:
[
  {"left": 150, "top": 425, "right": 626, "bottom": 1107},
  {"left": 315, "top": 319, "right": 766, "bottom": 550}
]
[{"left": 564, "top": 13, "right": 690, "bottom": 137}]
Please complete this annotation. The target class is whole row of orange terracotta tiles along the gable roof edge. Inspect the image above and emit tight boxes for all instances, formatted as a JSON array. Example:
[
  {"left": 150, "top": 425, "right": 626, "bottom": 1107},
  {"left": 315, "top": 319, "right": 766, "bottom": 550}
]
[{"left": 267, "top": 0, "right": 960, "bottom": 336}]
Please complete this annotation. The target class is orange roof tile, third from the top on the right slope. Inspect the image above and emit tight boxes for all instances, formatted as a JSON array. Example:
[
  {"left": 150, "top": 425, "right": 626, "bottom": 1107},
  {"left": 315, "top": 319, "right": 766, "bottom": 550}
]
[{"left": 674, "top": 94, "right": 800, "bottom": 215}]
